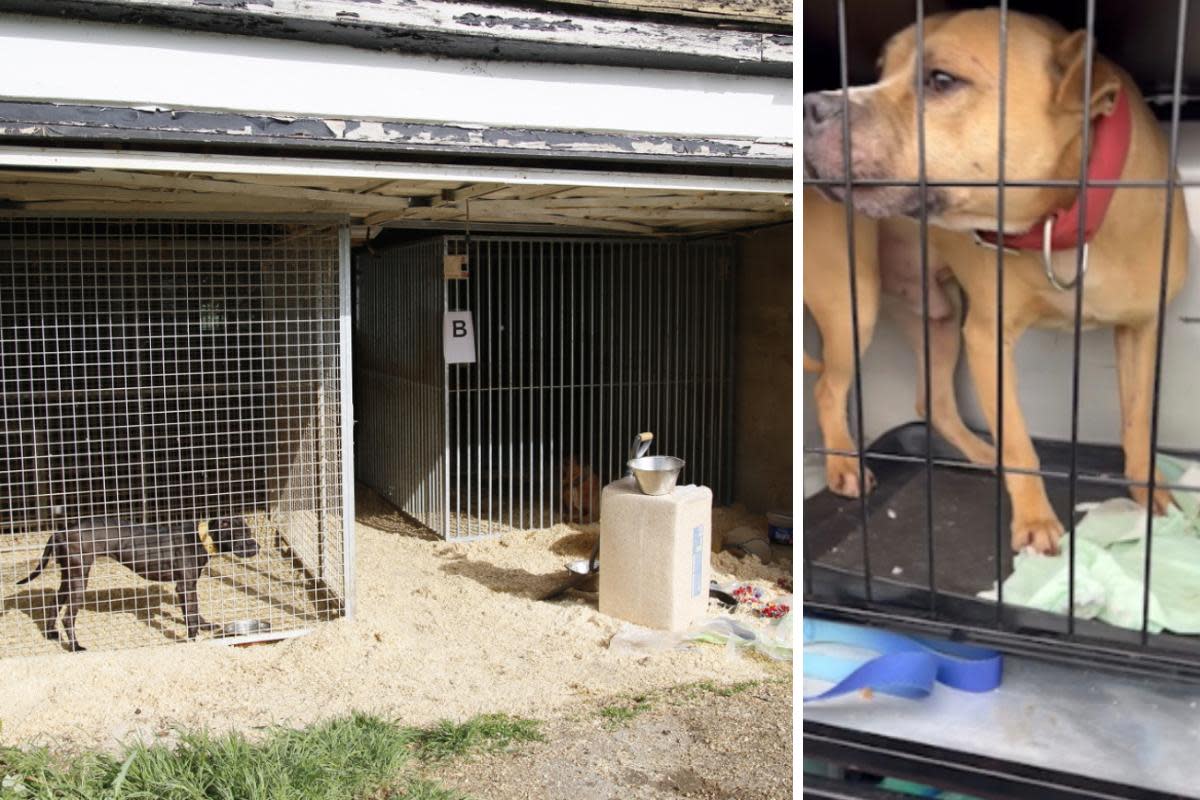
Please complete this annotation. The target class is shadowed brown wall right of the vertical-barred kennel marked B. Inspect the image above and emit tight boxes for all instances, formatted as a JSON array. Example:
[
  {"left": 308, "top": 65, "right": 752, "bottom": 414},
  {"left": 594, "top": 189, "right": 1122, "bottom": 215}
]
[{"left": 733, "top": 225, "right": 793, "bottom": 511}]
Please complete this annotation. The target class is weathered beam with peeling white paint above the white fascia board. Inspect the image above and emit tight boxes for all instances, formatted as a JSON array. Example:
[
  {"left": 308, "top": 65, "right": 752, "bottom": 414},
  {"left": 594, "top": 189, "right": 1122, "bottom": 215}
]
[{"left": 4, "top": 0, "right": 793, "bottom": 77}]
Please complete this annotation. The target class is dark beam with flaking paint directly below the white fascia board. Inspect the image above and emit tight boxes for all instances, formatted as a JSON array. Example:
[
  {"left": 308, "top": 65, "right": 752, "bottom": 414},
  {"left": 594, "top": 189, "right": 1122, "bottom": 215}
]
[{"left": 0, "top": 102, "right": 792, "bottom": 167}]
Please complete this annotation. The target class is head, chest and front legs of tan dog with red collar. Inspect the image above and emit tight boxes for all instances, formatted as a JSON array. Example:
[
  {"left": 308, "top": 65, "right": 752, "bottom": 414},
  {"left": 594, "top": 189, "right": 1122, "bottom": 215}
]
[{"left": 804, "top": 10, "right": 1188, "bottom": 553}]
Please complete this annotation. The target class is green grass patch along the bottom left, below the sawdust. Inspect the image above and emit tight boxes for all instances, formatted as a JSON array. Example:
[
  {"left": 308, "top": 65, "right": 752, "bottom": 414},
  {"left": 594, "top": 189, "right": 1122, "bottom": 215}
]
[{"left": 0, "top": 715, "right": 540, "bottom": 800}]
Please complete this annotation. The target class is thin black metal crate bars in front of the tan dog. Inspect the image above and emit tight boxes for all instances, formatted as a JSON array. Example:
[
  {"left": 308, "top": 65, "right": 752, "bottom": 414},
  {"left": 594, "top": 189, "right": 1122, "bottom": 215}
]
[{"left": 803, "top": 0, "right": 1198, "bottom": 668}]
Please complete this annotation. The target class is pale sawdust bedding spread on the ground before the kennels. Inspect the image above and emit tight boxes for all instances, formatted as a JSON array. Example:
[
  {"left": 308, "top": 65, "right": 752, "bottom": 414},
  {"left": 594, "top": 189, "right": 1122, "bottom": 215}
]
[{"left": 0, "top": 484, "right": 791, "bottom": 751}]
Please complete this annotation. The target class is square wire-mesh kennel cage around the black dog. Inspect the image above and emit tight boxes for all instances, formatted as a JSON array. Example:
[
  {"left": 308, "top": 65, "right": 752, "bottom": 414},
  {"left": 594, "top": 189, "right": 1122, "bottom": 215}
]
[{"left": 0, "top": 216, "right": 353, "bottom": 656}]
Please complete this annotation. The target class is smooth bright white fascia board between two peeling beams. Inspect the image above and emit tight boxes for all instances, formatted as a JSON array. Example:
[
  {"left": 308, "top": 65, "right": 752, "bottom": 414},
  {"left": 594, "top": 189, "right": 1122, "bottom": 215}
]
[{"left": 0, "top": 14, "right": 793, "bottom": 142}]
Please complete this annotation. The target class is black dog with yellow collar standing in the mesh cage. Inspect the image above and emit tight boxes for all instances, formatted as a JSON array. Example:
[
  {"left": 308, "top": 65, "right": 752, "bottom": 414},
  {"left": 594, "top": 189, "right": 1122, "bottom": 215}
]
[{"left": 17, "top": 517, "right": 258, "bottom": 652}]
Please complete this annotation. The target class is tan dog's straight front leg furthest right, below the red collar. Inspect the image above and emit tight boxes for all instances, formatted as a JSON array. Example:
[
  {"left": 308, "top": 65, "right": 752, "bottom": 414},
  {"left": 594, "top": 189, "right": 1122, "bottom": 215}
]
[{"left": 1114, "top": 318, "right": 1172, "bottom": 513}]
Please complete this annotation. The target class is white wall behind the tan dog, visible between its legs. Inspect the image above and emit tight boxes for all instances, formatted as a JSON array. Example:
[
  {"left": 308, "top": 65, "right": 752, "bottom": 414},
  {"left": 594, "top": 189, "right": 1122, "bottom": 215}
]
[{"left": 804, "top": 122, "right": 1200, "bottom": 494}]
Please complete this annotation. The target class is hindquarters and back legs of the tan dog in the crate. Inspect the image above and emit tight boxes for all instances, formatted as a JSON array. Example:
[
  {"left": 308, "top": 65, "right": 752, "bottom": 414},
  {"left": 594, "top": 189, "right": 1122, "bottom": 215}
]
[{"left": 804, "top": 190, "right": 996, "bottom": 497}]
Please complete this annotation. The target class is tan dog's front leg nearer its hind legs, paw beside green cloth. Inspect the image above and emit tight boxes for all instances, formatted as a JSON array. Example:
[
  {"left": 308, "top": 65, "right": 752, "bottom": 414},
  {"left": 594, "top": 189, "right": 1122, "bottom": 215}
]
[{"left": 962, "top": 303, "right": 1062, "bottom": 553}]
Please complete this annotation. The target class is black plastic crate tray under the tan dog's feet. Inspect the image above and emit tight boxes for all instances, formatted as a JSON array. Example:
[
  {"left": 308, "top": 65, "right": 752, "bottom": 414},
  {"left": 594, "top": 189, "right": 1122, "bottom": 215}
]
[{"left": 804, "top": 422, "right": 1200, "bottom": 678}]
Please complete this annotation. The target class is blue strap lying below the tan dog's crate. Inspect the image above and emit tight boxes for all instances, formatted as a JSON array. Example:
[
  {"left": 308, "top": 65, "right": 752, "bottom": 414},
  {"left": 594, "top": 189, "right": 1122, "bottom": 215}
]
[{"left": 804, "top": 616, "right": 1003, "bottom": 703}]
